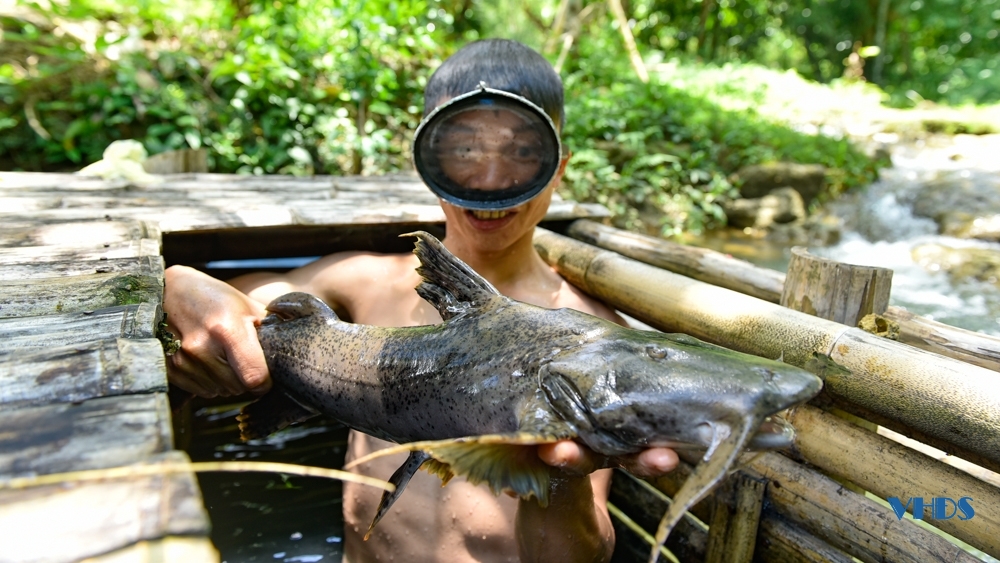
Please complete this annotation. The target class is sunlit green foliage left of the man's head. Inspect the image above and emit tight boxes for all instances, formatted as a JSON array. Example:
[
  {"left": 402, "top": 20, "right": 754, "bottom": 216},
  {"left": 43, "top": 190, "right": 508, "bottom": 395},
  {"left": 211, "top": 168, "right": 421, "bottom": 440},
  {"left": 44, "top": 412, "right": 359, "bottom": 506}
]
[{"left": 0, "top": 0, "right": 453, "bottom": 174}]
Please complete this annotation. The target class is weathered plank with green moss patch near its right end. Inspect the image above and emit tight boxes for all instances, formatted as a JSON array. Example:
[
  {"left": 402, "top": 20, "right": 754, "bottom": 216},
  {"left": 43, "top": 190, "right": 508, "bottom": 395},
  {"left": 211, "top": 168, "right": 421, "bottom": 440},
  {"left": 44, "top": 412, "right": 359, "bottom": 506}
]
[{"left": 0, "top": 261, "right": 163, "bottom": 318}]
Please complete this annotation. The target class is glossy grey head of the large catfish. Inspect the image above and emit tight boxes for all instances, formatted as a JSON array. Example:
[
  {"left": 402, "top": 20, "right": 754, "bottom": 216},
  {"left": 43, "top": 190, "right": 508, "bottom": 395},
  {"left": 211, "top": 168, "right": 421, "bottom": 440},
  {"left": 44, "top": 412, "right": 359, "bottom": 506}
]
[{"left": 539, "top": 327, "right": 822, "bottom": 455}]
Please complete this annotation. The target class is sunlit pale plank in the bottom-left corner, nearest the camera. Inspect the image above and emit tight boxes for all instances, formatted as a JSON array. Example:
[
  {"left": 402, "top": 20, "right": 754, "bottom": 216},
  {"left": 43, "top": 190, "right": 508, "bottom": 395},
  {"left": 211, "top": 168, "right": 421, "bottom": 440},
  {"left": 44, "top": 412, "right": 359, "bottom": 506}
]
[{"left": 0, "top": 452, "right": 211, "bottom": 563}]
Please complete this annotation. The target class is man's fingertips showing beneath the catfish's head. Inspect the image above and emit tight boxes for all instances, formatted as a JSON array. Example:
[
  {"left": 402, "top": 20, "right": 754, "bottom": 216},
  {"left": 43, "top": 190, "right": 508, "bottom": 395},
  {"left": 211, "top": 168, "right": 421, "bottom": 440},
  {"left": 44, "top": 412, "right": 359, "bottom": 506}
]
[{"left": 538, "top": 440, "right": 678, "bottom": 477}]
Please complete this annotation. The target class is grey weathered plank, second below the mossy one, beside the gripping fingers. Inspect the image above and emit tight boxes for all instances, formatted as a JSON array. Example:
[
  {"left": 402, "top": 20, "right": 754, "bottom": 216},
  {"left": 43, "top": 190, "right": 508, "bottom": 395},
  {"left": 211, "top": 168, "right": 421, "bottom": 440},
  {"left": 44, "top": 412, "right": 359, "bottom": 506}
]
[{"left": 0, "top": 338, "right": 167, "bottom": 409}]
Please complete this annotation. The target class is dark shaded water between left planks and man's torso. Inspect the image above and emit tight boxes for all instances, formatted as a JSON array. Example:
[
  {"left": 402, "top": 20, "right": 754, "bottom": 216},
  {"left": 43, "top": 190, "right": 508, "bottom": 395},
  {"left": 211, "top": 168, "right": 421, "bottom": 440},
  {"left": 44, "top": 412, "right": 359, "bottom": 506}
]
[{"left": 178, "top": 399, "right": 348, "bottom": 563}]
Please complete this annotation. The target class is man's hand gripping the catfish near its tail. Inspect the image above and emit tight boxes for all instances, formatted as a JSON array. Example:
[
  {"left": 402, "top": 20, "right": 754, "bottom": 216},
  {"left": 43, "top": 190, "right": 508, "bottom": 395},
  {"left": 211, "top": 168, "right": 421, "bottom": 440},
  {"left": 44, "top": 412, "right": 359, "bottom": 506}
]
[{"left": 163, "top": 266, "right": 271, "bottom": 397}]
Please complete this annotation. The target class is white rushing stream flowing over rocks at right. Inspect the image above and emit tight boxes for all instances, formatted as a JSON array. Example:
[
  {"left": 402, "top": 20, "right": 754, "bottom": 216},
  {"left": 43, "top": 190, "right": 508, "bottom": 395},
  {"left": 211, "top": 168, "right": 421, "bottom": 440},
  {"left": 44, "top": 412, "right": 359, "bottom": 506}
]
[{"left": 695, "top": 135, "right": 1000, "bottom": 336}]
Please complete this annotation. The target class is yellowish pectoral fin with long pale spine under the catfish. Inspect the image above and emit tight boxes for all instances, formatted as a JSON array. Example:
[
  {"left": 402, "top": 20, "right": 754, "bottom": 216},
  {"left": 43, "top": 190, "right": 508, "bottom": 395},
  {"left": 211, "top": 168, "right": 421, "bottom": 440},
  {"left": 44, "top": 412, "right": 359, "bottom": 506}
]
[{"left": 345, "top": 432, "right": 560, "bottom": 506}]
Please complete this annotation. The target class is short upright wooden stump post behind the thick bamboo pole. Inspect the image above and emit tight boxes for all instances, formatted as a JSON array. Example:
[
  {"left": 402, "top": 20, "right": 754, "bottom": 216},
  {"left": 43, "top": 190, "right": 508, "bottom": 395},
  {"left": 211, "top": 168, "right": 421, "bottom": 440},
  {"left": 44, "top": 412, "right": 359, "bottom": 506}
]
[{"left": 780, "top": 246, "right": 892, "bottom": 326}]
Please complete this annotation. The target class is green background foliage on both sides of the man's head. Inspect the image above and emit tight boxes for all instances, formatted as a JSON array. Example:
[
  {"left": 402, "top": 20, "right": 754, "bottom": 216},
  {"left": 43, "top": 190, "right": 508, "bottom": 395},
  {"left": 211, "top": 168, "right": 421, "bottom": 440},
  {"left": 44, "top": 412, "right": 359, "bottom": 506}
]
[{"left": 0, "top": 0, "right": 888, "bottom": 234}]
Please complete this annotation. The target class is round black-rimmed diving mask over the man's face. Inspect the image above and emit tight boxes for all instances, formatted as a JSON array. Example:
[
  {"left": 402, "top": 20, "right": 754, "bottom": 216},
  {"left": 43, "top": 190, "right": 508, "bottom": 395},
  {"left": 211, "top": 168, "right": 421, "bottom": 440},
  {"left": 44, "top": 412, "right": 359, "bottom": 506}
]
[{"left": 413, "top": 89, "right": 560, "bottom": 210}]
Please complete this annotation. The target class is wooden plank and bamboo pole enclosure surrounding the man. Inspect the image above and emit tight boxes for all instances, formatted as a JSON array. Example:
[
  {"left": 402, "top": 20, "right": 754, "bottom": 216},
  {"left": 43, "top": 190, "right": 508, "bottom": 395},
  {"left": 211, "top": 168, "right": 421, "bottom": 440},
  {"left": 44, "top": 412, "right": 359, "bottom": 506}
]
[{"left": 0, "top": 173, "right": 1000, "bottom": 562}]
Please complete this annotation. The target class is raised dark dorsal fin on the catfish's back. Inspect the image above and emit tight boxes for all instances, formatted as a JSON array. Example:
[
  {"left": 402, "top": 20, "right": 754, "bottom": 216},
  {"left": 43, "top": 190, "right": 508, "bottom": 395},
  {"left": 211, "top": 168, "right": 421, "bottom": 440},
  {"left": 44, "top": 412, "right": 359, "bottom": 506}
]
[{"left": 400, "top": 231, "right": 500, "bottom": 320}]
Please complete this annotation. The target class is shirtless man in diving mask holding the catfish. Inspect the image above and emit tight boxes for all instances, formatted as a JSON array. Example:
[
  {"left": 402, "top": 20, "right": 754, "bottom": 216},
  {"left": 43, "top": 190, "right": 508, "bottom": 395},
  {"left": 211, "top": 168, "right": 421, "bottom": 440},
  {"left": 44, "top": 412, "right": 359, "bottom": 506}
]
[{"left": 164, "top": 40, "right": 677, "bottom": 563}]
